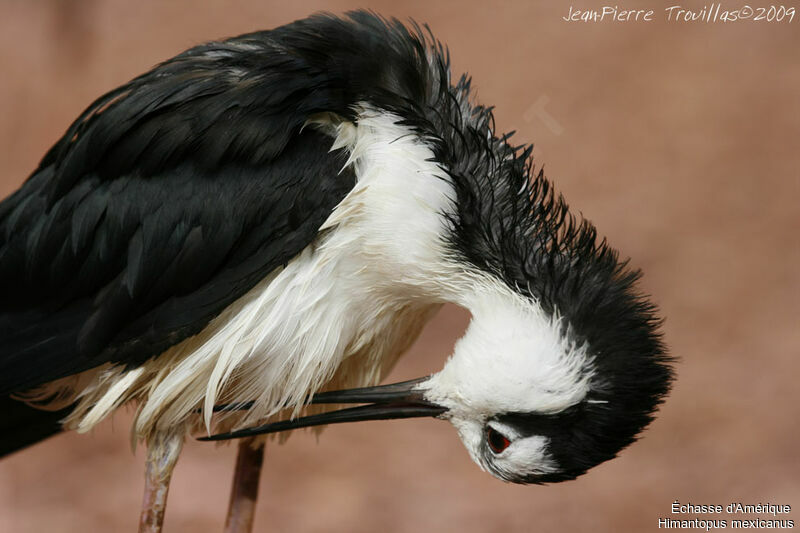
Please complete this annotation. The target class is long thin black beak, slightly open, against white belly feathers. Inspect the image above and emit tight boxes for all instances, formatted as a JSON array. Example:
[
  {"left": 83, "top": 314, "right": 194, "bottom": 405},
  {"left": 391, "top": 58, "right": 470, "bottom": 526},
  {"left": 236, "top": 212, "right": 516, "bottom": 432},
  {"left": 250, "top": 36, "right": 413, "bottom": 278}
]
[{"left": 194, "top": 377, "right": 447, "bottom": 441}]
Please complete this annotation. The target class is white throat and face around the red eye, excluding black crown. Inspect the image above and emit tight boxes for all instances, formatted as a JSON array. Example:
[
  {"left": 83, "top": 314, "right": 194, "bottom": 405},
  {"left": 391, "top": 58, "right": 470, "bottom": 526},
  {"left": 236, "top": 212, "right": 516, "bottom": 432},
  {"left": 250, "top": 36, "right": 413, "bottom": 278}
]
[{"left": 419, "top": 291, "right": 593, "bottom": 481}]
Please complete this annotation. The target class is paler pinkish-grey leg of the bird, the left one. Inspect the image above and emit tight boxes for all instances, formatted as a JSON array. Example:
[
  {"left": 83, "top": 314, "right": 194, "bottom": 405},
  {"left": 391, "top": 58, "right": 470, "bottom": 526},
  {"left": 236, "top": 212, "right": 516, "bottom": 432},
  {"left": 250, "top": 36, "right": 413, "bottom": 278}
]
[{"left": 139, "top": 433, "right": 183, "bottom": 533}]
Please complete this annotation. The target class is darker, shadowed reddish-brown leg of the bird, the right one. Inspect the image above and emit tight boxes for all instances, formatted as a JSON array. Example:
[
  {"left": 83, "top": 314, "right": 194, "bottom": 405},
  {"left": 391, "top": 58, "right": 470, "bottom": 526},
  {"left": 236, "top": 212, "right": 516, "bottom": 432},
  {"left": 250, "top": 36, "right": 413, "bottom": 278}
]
[{"left": 225, "top": 437, "right": 264, "bottom": 533}]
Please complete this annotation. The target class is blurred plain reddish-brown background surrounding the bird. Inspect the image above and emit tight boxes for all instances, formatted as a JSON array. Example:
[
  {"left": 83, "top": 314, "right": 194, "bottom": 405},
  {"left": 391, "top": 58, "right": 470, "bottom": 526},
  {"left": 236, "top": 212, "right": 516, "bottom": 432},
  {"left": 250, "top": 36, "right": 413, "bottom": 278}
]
[{"left": 0, "top": 0, "right": 800, "bottom": 533}]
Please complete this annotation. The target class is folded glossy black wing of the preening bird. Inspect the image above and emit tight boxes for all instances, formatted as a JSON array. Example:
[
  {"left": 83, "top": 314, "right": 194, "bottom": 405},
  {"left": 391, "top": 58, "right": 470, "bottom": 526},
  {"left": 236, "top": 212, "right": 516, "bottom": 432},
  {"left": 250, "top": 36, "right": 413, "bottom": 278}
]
[{"left": 0, "top": 34, "right": 354, "bottom": 394}]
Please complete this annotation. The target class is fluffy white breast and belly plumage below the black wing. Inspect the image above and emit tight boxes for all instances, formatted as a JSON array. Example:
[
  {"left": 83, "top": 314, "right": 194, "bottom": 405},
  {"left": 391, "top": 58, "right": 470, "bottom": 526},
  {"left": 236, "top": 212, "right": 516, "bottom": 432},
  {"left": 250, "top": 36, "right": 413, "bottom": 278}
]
[{"left": 50, "top": 107, "right": 459, "bottom": 439}]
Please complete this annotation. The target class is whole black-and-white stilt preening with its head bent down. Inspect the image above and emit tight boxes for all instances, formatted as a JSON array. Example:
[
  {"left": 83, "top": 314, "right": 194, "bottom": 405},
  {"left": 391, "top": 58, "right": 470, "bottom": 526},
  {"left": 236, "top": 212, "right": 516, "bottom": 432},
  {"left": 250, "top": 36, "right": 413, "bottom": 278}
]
[{"left": 0, "top": 12, "right": 672, "bottom": 530}]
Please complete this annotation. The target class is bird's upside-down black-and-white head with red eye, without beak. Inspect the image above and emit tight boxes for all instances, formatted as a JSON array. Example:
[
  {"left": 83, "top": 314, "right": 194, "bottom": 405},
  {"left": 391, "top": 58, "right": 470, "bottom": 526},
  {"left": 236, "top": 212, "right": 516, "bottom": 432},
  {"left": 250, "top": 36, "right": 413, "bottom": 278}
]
[{"left": 417, "top": 276, "right": 670, "bottom": 483}]
